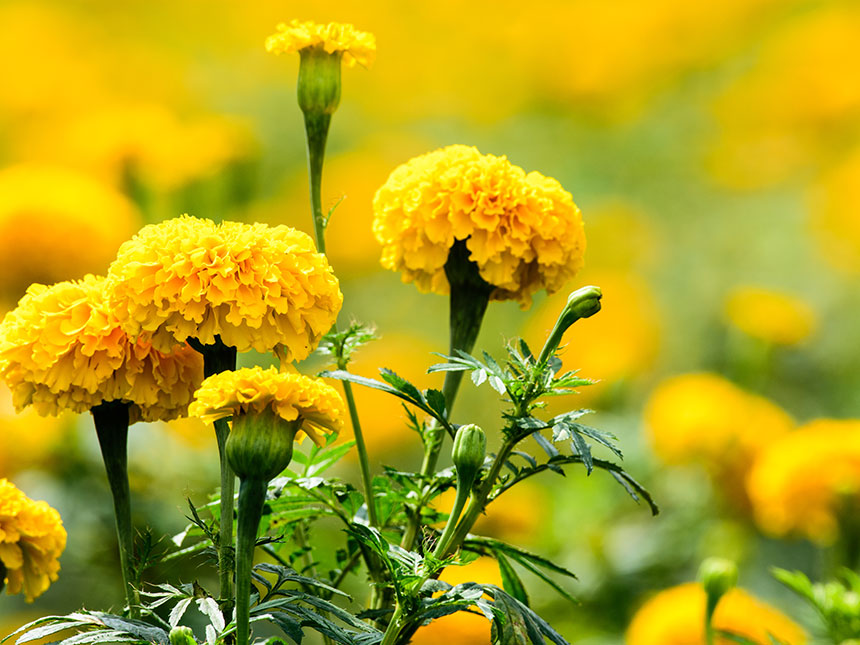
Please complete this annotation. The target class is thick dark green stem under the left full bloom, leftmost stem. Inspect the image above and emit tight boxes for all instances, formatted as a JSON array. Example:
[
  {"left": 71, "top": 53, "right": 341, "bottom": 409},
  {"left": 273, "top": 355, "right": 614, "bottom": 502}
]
[{"left": 92, "top": 401, "right": 140, "bottom": 618}]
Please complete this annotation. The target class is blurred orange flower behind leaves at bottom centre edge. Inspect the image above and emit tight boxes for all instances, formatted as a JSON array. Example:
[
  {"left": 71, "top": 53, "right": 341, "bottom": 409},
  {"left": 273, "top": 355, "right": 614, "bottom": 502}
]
[{"left": 409, "top": 557, "right": 502, "bottom": 645}]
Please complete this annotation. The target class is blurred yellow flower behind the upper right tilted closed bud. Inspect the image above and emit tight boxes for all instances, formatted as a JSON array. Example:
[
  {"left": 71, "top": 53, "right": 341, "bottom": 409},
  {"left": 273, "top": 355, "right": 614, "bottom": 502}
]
[{"left": 523, "top": 271, "right": 661, "bottom": 402}]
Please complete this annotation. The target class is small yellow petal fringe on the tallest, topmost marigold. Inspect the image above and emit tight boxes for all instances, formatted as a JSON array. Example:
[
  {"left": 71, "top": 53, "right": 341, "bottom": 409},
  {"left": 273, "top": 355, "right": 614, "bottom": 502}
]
[{"left": 266, "top": 20, "right": 376, "bottom": 67}]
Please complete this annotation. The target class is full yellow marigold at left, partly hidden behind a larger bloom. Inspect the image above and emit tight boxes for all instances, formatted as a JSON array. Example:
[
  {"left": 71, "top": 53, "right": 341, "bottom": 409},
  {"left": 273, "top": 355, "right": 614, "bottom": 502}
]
[{"left": 0, "top": 275, "right": 203, "bottom": 423}]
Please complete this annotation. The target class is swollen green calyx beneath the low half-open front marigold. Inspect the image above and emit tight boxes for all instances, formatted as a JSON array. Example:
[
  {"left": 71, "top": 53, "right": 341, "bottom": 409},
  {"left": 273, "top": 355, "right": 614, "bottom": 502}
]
[{"left": 226, "top": 410, "right": 302, "bottom": 481}]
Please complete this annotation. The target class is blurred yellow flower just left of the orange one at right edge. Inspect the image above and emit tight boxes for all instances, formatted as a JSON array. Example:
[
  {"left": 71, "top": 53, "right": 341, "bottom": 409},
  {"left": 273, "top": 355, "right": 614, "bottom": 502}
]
[{"left": 644, "top": 373, "right": 794, "bottom": 508}]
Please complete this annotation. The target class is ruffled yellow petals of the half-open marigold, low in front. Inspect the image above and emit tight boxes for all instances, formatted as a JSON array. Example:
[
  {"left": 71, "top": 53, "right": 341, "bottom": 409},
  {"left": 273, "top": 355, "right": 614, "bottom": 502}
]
[{"left": 189, "top": 367, "right": 344, "bottom": 442}]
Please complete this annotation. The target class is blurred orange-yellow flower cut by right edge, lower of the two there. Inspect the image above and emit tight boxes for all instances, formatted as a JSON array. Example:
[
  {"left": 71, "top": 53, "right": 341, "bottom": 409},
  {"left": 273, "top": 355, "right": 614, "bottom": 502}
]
[{"left": 747, "top": 419, "right": 860, "bottom": 544}]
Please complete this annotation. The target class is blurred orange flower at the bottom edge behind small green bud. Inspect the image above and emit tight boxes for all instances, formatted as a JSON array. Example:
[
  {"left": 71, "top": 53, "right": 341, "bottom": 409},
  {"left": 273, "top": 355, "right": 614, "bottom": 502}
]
[{"left": 625, "top": 582, "right": 806, "bottom": 645}]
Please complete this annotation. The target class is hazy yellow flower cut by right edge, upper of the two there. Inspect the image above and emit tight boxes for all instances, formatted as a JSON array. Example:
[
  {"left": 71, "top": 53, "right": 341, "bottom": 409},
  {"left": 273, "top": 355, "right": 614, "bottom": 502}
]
[{"left": 810, "top": 149, "right": 860, "bottom": 275}]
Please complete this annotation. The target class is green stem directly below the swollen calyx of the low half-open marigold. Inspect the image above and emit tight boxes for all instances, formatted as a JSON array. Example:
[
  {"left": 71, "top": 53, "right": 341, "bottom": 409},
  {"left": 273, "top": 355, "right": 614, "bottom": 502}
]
[{"left": 236, "top": 477, "right": 268, "bottom": 645}]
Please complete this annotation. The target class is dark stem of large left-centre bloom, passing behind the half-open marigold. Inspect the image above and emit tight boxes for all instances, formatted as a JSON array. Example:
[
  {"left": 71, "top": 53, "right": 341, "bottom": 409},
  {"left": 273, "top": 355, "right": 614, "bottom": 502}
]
[{"left": 188, "top": 336, "right": 236, "bottom": 615}]
